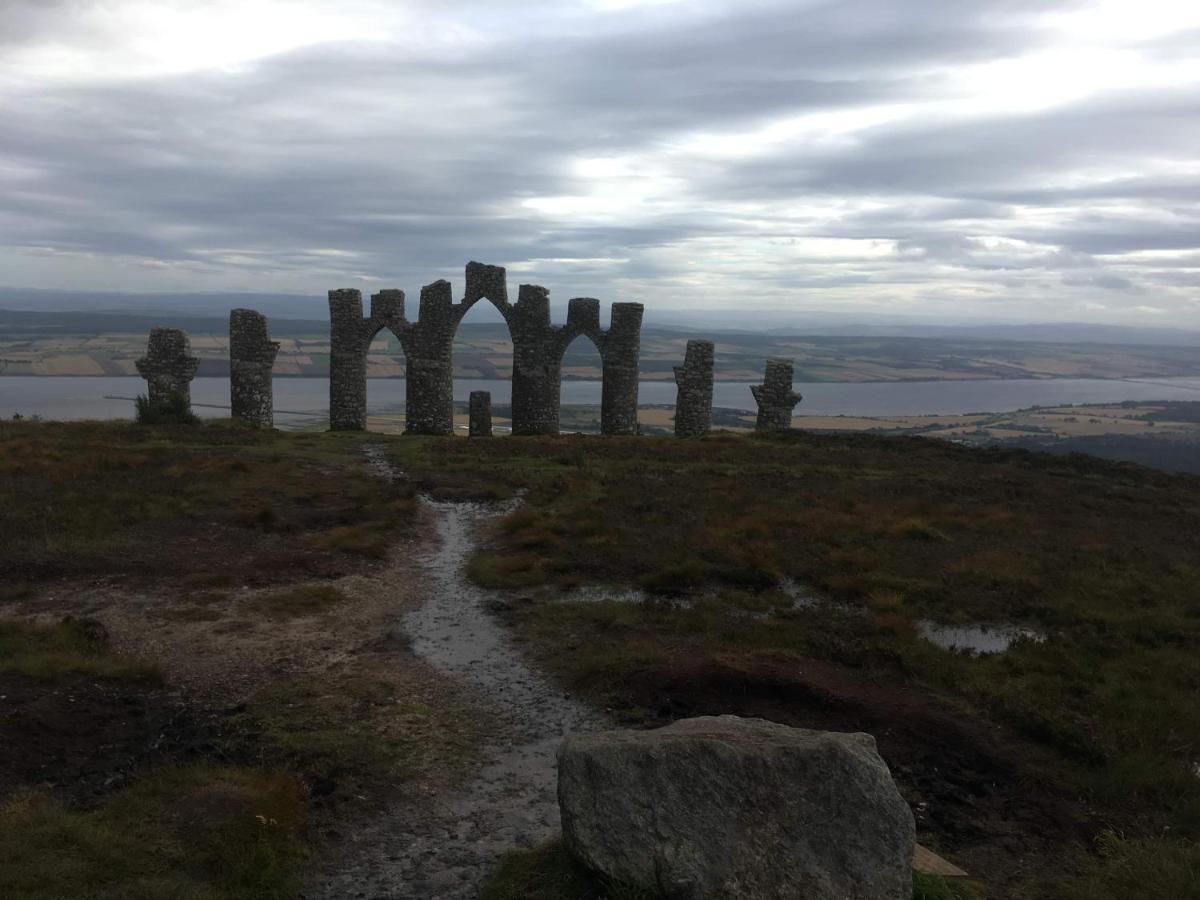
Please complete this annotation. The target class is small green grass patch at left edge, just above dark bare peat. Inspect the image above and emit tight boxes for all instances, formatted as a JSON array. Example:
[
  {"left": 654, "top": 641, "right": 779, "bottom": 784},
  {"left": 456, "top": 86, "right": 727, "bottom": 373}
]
[{"left": 0, "top": 618, "right": 162, "bottom": 682}]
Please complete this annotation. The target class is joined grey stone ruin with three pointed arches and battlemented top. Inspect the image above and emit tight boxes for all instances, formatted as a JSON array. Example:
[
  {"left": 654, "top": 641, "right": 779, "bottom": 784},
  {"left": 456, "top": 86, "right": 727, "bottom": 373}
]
[{"left": 329, "top": 263, "right": 643, "bottom": 434}]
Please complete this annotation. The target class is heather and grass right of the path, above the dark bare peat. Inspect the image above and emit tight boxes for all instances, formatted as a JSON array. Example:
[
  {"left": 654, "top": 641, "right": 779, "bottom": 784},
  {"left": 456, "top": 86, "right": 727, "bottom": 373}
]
[{"left": 390, "top": 433, "right": 1200, "bottom": 896}]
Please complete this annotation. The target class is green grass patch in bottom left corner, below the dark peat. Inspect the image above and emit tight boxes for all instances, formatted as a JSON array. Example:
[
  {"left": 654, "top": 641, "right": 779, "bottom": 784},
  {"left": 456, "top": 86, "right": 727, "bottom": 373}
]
[{"left": 0, "top": 767, "right": 305, "bottom": 900}]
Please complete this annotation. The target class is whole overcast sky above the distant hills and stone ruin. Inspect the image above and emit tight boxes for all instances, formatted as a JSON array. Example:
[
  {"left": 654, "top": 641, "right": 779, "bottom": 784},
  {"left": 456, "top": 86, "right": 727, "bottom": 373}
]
[{"left": 0, "top": 0, "right": 1200, "bottom": 328}]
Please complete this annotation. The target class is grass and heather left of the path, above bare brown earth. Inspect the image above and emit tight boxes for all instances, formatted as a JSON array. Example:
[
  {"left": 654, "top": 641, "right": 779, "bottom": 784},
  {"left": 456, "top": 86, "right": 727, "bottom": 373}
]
[{"left": 0, "top": 422, "right": 415, "bottom": 582}]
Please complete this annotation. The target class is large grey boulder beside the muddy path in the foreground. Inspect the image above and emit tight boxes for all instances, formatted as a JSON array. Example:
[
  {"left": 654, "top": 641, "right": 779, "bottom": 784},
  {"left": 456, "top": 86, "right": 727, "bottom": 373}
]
[{"left": 558, "top": 715, "right": 916, "bottom": 900}]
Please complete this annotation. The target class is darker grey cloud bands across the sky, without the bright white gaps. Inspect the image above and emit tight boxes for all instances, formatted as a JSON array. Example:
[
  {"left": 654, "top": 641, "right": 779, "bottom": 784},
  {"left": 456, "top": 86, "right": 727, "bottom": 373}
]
[{"left": 0, "top": 0, "right": 1200, "bottom": 324}]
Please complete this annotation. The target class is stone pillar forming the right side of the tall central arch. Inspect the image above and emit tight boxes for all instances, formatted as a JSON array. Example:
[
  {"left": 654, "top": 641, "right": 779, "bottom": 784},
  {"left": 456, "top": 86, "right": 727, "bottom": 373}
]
[{"left": 509, "top": 284, "right": 563, "bottom": 434}]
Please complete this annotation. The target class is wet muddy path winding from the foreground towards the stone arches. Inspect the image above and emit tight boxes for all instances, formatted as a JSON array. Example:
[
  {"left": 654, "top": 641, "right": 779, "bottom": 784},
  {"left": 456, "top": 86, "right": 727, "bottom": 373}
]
[{"left": 304, "top": 448, "right": 607, "bottom": 900}]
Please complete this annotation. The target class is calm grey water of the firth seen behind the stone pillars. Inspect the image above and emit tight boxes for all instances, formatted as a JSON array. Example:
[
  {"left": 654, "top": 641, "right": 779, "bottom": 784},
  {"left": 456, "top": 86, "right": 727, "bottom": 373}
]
[{"left": 0, "top": 377, "right": 1200, "bottom": 425}]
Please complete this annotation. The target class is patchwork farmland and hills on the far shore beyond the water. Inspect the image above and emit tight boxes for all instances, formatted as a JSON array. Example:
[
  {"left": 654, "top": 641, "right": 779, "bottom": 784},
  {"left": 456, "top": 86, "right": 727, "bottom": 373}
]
[{"left": 7, "top": 311, "right": 1200, "bottom": 382}]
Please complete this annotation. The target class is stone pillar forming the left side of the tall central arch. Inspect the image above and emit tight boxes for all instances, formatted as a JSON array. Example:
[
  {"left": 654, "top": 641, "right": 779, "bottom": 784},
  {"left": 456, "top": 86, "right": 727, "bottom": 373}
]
[{"left": 404, "top": 281, "right": 457, "bottom": 434}]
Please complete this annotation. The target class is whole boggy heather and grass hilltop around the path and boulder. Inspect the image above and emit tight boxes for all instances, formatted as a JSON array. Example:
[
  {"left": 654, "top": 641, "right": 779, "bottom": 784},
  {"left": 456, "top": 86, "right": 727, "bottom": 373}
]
[{"left": 0, "top": 422, "right": 1200, "bottom": 900}]
